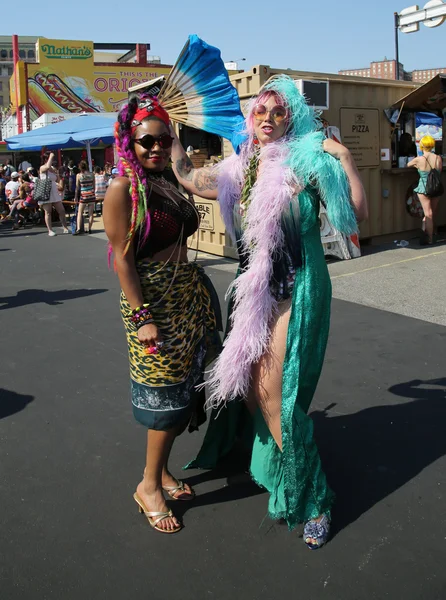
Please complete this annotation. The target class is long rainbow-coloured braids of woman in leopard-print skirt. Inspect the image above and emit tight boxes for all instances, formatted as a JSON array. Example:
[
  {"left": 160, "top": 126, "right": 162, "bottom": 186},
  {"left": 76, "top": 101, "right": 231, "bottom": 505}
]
[{"left": 115, "top": 94, "right": 170, "bottom": 254}]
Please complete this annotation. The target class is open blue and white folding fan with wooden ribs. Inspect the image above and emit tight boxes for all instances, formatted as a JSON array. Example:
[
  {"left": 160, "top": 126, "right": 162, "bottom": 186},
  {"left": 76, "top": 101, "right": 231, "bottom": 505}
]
[{"left": 159, "top": 35, "right": 244, "bottom": 149}]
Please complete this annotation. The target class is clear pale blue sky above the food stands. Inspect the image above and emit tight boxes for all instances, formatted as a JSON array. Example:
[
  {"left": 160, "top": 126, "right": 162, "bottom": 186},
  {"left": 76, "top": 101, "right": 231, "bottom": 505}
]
[{"left": 6, "top": 0, "right": 446, "bottom": 72}]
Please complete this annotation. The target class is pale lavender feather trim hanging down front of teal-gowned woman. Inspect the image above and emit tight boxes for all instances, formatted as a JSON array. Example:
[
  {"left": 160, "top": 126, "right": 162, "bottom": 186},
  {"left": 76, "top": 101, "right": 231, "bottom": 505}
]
[{"left": 207, "top": 143, "right": 302, "bottom": 407}]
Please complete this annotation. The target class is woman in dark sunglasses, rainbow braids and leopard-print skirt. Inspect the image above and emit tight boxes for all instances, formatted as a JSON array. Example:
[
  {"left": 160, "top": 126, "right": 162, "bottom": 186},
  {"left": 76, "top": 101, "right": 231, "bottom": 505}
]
[{"left": 104, "top": 95, "right": 222, "bottom": 533}]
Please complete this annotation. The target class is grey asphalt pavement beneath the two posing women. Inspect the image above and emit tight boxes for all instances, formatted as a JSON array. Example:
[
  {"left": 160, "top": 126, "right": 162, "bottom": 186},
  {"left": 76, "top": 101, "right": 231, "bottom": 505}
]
[{"left": 0, "top": 227, "right": 446, "bottom": 600}]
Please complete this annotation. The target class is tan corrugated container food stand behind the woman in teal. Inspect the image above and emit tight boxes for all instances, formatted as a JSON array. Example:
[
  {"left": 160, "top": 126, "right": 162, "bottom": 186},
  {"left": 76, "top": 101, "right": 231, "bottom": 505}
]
[{"left": 196, "top": 65, "right": 446, "bottom": 257}]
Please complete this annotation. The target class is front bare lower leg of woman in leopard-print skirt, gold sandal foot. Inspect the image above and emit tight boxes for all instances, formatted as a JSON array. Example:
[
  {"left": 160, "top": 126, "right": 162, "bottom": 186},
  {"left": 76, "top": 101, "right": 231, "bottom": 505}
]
[{"left": 136, "top": 429, "right": 179, "bottom": 530}]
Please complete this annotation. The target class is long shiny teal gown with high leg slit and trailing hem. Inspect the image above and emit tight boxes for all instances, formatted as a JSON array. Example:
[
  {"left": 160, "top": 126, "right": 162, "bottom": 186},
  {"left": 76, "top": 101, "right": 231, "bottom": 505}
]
[{"left": 185, "top": 188, "right": 334, "bottom": 529}]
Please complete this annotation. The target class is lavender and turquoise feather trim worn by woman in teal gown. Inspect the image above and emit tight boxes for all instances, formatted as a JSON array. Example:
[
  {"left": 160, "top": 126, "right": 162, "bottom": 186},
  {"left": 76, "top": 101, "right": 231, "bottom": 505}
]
[{"left": 204, "top": 75, "right": 357, "bottom": 407}]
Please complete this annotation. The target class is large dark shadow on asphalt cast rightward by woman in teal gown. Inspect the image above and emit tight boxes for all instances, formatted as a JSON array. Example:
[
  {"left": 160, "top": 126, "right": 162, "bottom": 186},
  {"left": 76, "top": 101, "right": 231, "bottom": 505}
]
[{"left": 311, "top": 378, "right": 446, "bottom": 533}]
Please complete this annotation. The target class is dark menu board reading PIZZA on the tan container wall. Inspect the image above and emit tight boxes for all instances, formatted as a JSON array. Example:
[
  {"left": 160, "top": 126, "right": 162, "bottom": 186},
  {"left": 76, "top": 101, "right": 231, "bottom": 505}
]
[{"left": 340, "top": 108, "right": 380, "bottom": 167}]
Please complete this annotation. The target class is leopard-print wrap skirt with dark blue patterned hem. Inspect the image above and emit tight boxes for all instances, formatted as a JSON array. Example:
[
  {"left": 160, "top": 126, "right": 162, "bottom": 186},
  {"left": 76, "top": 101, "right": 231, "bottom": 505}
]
[{"left": 121, "top": 261, "right": 220, "bottom": 431}]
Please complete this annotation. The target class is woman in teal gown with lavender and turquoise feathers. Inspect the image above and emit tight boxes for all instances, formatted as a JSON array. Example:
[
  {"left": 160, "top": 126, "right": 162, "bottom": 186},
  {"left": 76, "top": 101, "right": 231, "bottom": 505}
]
[{"left": 172, "top": 76, "right": 367, "bottom": 549}]
